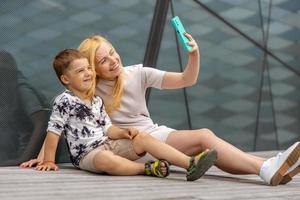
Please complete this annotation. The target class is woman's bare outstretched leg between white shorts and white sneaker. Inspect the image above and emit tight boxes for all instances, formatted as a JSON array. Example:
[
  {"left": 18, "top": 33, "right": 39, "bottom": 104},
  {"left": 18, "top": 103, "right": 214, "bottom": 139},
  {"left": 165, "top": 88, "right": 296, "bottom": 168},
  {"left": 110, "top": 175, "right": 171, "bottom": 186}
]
[{"left": 166, "top": 129, "right": 264, "bottom": 175}]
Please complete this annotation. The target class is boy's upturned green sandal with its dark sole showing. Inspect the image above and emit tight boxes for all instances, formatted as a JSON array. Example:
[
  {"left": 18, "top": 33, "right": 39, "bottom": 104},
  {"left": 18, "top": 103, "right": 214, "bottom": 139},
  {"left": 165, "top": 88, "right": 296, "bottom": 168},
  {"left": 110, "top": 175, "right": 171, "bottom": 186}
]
[{"left": 186, "top": 149, "right": 217, "bottom": 181}]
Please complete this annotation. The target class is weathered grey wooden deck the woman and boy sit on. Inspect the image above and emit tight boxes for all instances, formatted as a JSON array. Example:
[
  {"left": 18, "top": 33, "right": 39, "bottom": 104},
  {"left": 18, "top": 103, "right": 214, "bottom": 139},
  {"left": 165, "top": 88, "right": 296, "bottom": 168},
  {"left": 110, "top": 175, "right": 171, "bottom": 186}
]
[{"left": 0, "top": 152, "right": 300, "bottom": 200}]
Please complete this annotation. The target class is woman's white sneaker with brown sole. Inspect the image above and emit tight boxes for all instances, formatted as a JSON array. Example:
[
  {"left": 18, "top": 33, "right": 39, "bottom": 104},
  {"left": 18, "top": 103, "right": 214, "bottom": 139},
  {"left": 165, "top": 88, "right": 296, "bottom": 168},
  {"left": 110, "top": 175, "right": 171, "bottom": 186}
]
[{"left": 259, "top": 142, "right": 300, "bottom": 186}]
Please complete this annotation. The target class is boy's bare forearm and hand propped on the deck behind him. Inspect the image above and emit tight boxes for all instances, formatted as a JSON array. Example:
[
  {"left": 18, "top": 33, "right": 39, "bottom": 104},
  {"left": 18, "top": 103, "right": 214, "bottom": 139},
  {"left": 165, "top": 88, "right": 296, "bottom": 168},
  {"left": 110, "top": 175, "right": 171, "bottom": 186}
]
[{"left": 36, "top": 131, "right": 59, "bottom": 171}]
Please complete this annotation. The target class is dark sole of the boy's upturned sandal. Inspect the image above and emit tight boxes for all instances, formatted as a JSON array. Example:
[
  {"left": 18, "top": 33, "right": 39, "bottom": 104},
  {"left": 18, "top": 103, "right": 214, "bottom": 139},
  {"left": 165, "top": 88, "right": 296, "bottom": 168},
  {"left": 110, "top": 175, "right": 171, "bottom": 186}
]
[{"left": 187, "top": 149, "right": 217, "bottom": 181}]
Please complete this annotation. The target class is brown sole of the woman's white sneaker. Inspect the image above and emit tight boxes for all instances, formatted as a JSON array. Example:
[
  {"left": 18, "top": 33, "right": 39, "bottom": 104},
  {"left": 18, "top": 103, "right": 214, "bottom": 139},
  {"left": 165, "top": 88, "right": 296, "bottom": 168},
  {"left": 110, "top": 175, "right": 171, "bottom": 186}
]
[{"left": 270, "top": 142, "right": 300, "bottom": 186}]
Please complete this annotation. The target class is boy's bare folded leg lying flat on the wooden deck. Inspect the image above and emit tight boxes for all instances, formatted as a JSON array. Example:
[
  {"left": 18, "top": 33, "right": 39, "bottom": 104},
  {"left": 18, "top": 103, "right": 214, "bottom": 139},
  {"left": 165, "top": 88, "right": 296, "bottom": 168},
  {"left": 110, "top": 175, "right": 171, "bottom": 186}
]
[{"left": 94, "top": 151, "right": 145, "bottom": 176}]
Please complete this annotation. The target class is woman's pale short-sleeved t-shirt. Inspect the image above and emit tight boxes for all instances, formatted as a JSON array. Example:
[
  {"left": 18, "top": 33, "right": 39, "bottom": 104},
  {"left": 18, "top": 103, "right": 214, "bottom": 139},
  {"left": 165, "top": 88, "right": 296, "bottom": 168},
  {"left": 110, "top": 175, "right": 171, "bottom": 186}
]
[{"left": 96, "top": 64, "right": 165, "bottom": 133}]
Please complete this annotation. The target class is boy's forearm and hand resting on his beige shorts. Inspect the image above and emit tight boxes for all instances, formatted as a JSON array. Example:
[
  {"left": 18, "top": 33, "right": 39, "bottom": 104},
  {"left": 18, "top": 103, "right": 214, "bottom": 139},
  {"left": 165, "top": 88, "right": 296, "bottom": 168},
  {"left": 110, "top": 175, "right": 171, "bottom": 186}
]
[{"left": 107, "top": 125, "right": 139, "bottom": 140}]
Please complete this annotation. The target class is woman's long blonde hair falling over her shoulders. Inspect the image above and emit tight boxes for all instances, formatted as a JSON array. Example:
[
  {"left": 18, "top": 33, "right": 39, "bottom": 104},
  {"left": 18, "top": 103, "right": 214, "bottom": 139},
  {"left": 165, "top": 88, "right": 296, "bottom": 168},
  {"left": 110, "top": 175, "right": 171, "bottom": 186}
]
[{"left": 78, "top": 35, "right": 125, "bottom": 114}]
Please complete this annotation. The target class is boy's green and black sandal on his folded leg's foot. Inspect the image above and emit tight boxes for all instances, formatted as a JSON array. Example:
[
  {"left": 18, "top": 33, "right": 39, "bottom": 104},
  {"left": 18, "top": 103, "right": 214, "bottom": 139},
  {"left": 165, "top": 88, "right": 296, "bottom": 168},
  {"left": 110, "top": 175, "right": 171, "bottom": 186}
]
[{"left": 145, "top": 160, "right": 170, "bottom": 178}]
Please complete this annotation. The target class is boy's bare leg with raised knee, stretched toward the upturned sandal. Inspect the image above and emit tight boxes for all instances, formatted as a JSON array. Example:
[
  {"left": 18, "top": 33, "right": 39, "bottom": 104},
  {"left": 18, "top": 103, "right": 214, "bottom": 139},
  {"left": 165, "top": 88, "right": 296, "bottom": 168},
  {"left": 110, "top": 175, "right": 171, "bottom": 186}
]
[{"left": 133, "top": 133, "right": 190, "bottom": 169}]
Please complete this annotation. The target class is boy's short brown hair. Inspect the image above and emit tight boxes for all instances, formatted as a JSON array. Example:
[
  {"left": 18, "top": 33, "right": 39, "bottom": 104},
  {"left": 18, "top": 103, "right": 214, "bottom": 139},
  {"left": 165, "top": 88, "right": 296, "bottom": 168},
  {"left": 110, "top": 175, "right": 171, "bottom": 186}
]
[{"left": 53, "top": 49, "right": 86, "bottom": 85}]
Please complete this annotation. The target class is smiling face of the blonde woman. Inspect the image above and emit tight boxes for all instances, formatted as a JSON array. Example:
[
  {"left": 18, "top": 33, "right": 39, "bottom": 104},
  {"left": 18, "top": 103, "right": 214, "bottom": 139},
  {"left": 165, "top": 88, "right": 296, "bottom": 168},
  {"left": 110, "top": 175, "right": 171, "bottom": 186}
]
[{"left": 95, "top": 42, "right": 123, "bottom": 80}]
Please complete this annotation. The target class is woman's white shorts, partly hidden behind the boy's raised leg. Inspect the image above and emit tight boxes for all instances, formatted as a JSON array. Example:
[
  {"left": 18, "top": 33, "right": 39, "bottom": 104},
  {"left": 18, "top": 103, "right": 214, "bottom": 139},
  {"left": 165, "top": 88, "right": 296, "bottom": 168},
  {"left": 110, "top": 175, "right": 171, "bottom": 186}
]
[{"left": 136, "top": 125, "right": 176, "bottom": 163}]
